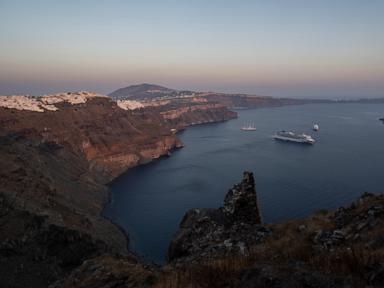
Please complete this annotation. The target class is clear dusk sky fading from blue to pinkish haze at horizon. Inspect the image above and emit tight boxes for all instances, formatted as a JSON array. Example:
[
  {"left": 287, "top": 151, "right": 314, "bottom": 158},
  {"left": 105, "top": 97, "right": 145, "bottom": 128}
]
[{"left": 0, "top": 0, "right": 384, "bottom": 98}]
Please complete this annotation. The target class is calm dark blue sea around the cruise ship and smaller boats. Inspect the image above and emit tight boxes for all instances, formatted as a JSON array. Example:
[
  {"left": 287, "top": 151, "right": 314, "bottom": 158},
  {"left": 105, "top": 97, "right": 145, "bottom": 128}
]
[{"left": 105, "top": 104, "right": 384, "bottom": 262}]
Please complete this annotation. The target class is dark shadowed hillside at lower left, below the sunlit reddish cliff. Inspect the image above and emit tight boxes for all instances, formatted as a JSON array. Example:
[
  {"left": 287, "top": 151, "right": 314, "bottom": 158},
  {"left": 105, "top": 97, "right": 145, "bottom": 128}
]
[{"left": 0, "top": 133, "right": 127, "bottom": 287}]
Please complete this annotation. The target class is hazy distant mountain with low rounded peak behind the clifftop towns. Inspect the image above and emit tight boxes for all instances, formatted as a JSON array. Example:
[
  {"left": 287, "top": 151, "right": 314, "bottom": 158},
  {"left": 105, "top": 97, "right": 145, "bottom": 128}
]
[{"left": 108, "top": 83, "right": 191, "bottom": 100}]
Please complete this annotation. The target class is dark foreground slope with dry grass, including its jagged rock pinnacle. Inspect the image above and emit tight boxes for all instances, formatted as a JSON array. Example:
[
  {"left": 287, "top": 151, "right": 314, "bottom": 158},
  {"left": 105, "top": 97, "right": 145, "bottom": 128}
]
[{"left": 52, "top": 172, "right": 384, "bottom": 288}]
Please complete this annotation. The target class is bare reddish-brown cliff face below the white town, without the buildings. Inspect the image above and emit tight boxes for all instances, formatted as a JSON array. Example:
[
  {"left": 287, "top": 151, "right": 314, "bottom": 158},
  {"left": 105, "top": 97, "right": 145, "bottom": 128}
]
[{"left": 0, "top": 97, "right": 181, "bottom": 180}]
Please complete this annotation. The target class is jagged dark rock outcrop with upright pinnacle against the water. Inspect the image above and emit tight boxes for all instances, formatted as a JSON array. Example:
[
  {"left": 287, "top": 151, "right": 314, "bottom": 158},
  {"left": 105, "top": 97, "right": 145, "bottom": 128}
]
[{"left": 168, "top": 172, "right": 269, "bottom": 263}]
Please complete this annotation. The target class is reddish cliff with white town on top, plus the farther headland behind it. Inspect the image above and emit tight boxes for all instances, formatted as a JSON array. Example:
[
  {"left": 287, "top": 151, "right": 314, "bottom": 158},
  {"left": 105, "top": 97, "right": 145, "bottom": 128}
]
[{"left": 0, "top": 92, "right": 236, "bottom": 180}]
